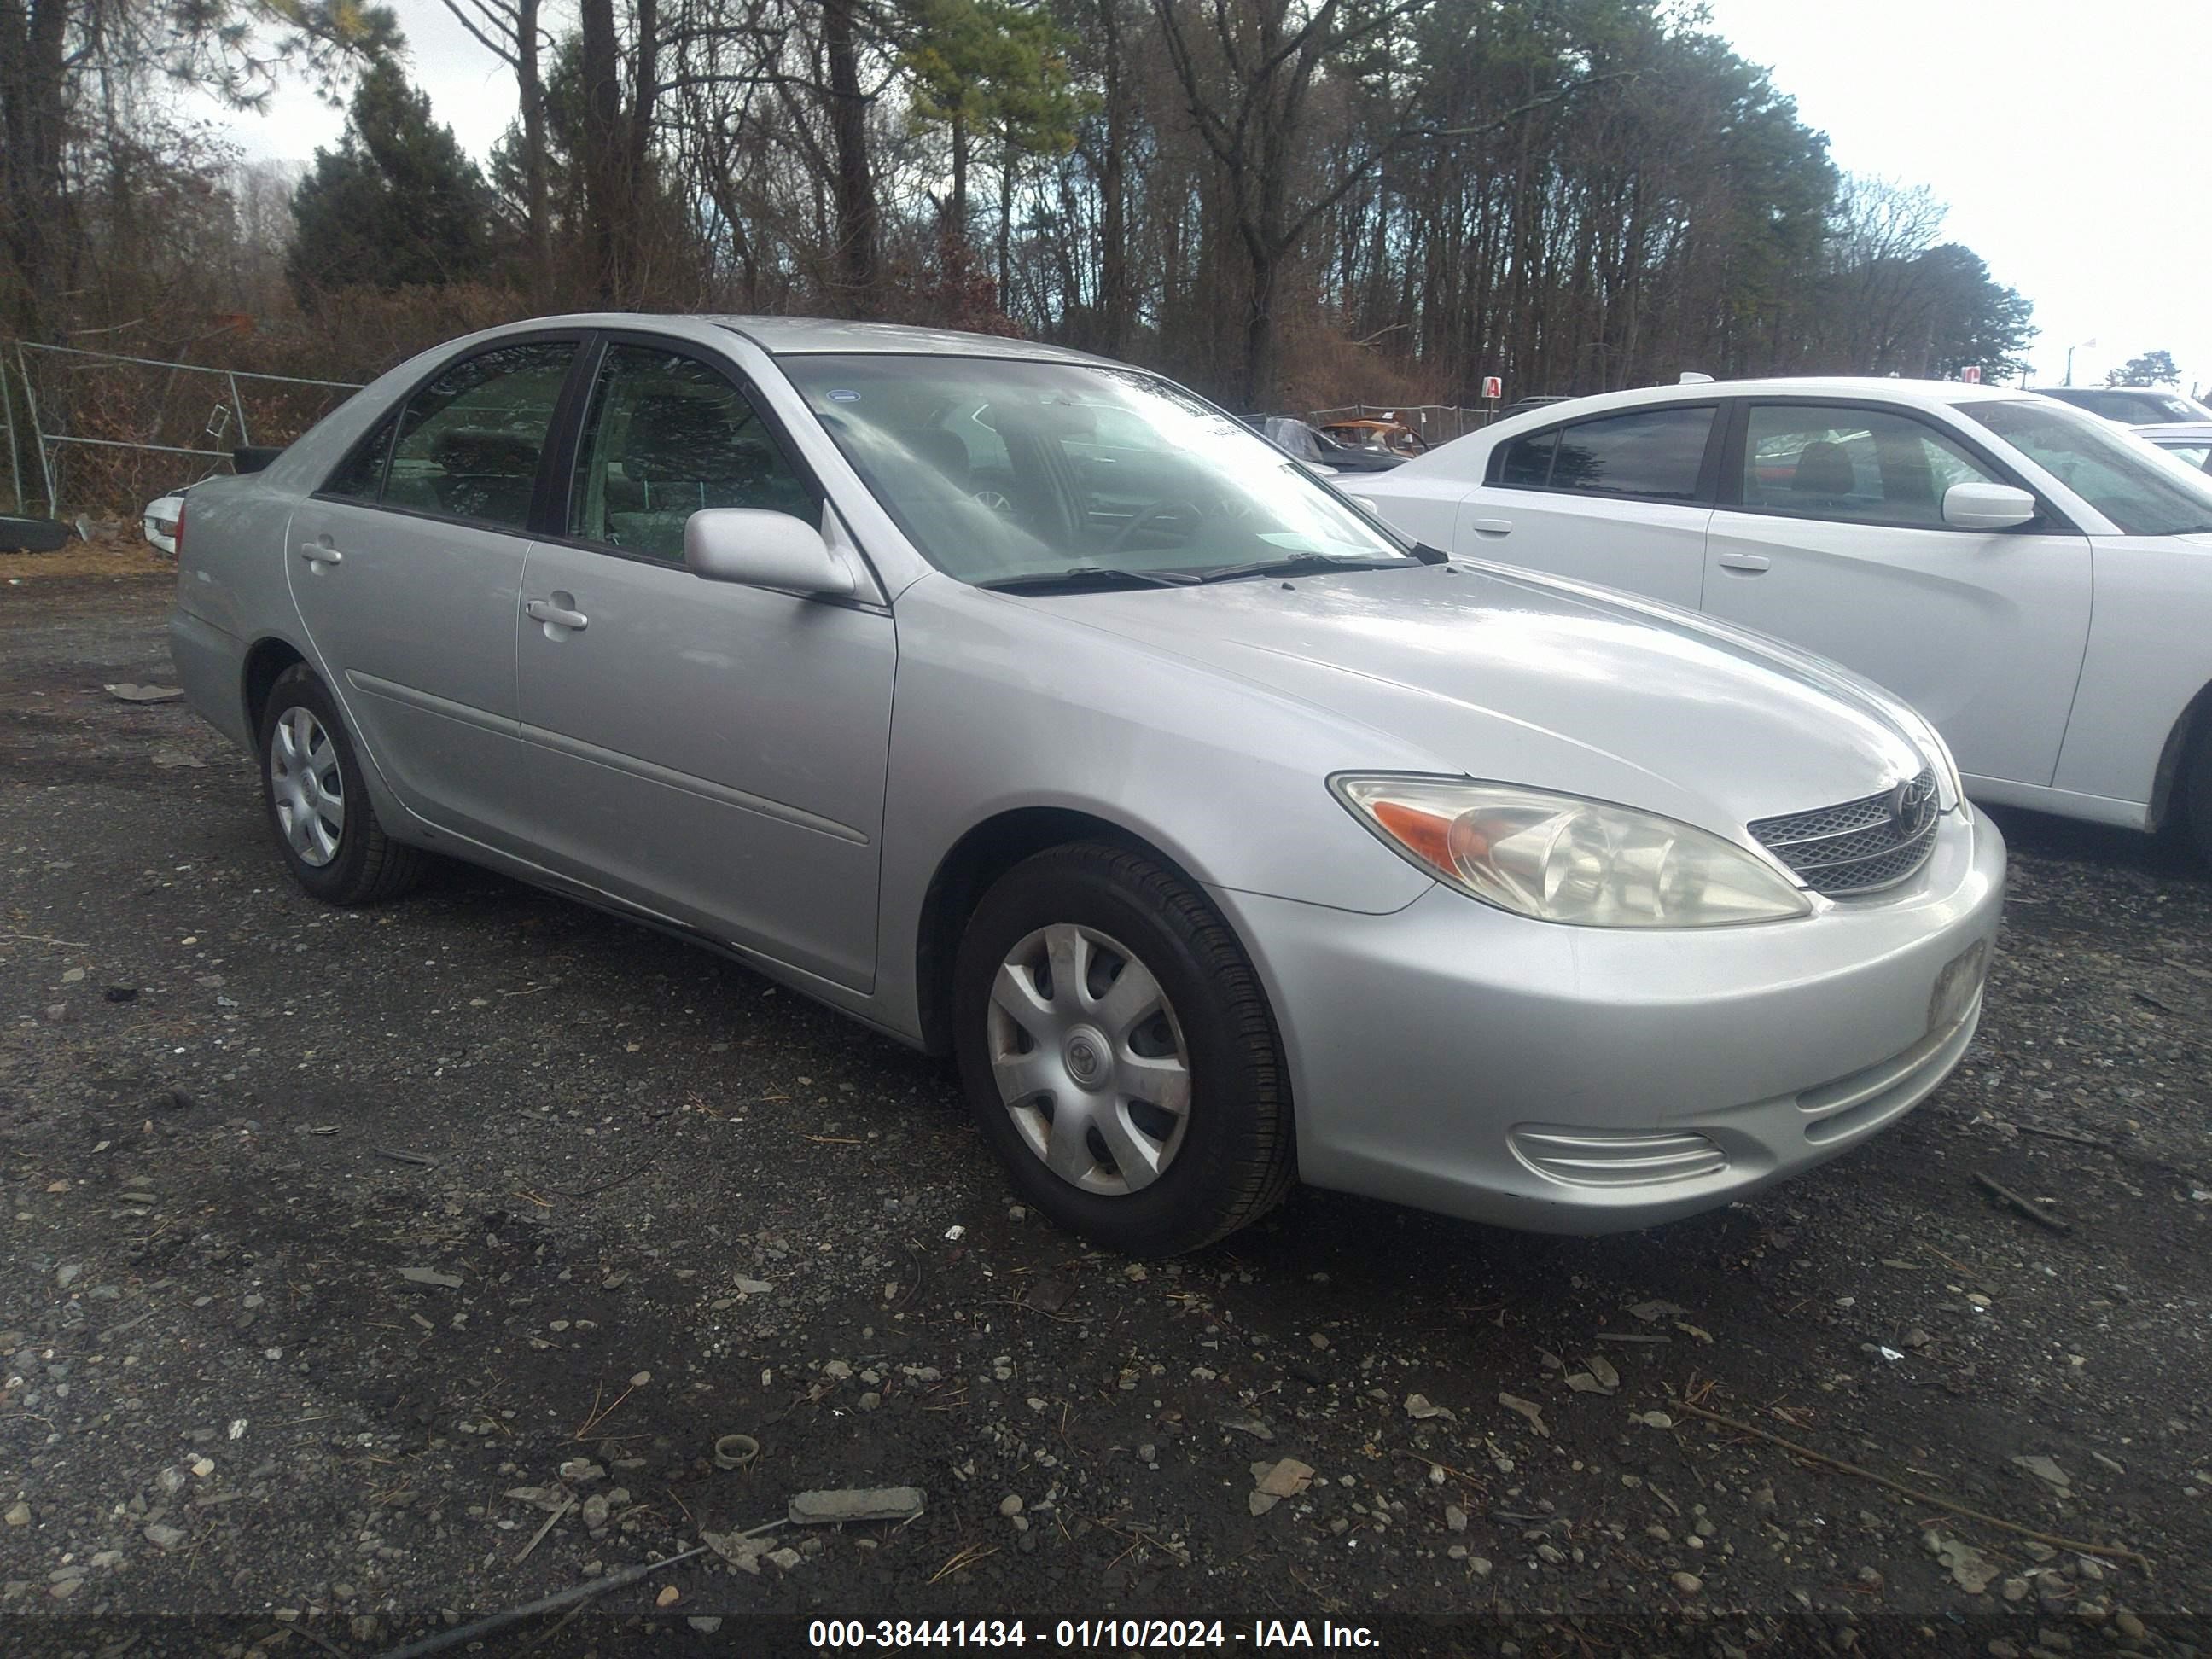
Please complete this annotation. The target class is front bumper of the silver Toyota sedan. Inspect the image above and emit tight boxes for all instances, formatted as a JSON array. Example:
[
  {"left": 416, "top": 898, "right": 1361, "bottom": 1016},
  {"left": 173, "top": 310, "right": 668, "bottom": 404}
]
[{"left": 1217, "top": 812, "right": 2004, "bottom": 1232}]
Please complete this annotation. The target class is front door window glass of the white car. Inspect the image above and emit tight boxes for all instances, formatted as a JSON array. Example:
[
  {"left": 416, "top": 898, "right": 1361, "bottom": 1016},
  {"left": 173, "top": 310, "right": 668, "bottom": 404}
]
[{"left": 1743, "top": 405, "right": 2004, "bottom": 528}]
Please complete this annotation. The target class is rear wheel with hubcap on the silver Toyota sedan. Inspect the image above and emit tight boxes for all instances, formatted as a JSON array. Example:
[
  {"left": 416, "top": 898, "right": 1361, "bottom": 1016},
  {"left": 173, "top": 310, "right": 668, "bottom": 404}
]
[{"left": 259, "top": 664, "right": 425, "bottom": 905}]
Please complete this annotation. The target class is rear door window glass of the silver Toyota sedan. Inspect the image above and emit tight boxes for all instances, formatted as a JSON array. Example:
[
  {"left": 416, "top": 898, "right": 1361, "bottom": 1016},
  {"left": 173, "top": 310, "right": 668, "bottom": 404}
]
[{"left": 382, "top": 341, "right": 575, "bottom": 531}]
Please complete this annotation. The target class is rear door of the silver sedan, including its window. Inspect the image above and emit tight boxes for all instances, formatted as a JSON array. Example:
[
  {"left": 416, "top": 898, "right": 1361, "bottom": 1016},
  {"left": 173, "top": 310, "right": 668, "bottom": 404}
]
[{"left": 285, "top": 334, "right": 579, "bottom": 849}]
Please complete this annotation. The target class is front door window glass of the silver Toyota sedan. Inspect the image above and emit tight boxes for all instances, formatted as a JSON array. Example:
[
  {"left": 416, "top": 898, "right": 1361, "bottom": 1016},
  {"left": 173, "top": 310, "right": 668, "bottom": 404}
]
[{"left": 568, "top": 345, "right": 821, "bottom": 562}]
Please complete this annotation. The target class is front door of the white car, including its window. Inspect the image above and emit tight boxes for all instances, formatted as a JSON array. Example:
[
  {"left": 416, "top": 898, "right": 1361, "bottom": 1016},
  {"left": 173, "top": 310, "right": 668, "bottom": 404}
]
[{"left": 1705, "top": 399, "right": 2090, "bottom": 785}]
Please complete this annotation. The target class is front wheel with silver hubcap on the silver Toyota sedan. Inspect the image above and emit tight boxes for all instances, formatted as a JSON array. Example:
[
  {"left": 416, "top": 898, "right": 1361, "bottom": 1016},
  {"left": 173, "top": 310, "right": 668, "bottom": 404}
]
[{"left": 953, "top": 843, "right": 1296, "bottom": 1256}]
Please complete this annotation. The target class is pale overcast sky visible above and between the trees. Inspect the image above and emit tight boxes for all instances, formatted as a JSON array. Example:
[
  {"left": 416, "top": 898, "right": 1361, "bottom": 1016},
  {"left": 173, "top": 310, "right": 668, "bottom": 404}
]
[{"left": 215, "top": 0, "right": 2212, "bottom": 387}]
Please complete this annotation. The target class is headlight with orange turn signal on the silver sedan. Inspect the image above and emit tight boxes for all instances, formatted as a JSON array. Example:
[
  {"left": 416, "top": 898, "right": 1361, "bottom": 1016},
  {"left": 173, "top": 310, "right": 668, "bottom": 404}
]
[{"left": 1330, "top": 774, "right": 1812, "bottom": 927}]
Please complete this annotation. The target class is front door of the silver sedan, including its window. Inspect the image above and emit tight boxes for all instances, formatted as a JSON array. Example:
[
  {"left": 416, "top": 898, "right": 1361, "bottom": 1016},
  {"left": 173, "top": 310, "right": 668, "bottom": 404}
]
[{"left": 518, "top": 343, "right": 896, "bottom": 991}]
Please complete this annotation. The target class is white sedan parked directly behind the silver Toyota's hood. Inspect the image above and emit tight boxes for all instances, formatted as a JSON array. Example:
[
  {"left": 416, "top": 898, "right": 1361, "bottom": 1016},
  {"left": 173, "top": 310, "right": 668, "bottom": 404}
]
[{"left": 1345, "top": 378, "right": 2212, "bottom": 859}]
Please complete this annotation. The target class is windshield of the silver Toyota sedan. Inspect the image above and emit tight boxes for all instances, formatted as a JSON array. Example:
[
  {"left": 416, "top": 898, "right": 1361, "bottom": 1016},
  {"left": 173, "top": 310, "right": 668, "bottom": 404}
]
[{"left": 781, "top": 354, "right": 1417, "bottom": 582}]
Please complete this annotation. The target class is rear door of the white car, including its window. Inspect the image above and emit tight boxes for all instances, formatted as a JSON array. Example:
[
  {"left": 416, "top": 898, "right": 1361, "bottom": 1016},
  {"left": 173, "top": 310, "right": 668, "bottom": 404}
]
[{"left": 1453, "top": 403, "right": 1721, "bottom": 610}]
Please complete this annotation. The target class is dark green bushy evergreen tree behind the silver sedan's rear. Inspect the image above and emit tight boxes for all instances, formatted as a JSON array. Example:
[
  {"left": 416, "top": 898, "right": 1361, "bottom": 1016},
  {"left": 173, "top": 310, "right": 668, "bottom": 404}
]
[{"left": 288, "top": 60, "right": 496, "bottom": 303}]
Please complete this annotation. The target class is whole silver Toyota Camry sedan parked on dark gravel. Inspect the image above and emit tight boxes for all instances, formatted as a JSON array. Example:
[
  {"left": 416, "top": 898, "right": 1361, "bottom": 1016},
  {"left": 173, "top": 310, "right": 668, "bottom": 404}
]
[{"left": 171, "top": 317, "right": 2004, "bottom": 1252}]
